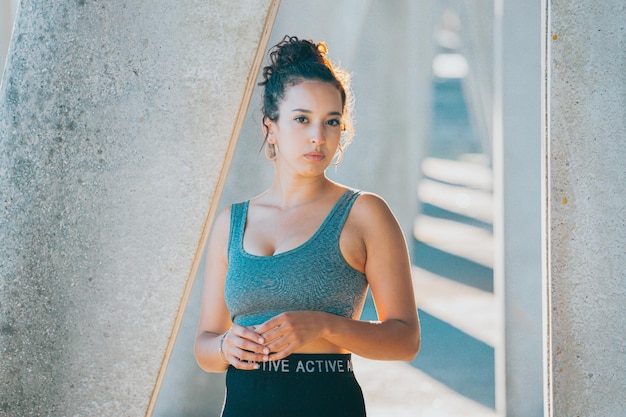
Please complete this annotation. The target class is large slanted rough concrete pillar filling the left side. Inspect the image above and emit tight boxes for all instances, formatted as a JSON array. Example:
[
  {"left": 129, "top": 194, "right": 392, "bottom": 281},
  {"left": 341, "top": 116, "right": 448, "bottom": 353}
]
[{"left": 0, "top": 0, "right": 276, "bottom": 416}]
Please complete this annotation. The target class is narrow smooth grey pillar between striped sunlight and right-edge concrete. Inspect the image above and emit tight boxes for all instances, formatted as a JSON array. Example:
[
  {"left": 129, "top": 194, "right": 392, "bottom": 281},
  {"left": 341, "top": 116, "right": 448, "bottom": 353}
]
[{"left": 493, "top": 0, "right": 543, "bottom": 417}]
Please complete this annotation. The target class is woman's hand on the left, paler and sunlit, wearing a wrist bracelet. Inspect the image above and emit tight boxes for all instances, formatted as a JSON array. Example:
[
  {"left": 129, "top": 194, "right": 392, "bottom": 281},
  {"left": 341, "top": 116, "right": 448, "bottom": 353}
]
[{"left": 220, "top": 324, "right": 270, "bottom": 370}]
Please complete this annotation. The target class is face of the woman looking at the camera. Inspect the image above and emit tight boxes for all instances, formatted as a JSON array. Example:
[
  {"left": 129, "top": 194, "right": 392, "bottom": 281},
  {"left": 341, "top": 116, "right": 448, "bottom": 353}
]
[{"left": 267, "top": 80, "right": 343, "bottom": 176}]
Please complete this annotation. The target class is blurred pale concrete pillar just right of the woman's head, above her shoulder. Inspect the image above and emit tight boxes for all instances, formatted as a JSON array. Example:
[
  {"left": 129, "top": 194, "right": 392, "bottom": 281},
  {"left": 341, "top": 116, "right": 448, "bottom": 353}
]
[{"left": 331, "top": 1, "right": 433, "bottom": 237}]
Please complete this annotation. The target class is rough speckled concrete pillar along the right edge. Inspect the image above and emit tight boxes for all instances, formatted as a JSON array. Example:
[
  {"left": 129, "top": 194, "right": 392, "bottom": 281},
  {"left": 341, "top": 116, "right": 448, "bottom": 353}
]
[{"left": 544, "top": 0, "right": 626, "bottom": 417}]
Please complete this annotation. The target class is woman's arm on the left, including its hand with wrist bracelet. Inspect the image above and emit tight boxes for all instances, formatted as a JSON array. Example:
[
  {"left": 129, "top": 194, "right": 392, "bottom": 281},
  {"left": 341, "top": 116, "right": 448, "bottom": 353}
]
[{"left": 194, "top": 210, "right": 269, "bottom": 372}]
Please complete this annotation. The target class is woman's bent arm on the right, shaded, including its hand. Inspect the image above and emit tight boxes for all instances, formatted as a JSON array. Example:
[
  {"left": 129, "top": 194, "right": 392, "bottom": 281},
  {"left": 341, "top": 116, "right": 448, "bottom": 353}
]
[{"left": 256, "top": 194, "right": 420, "bottom": 361}]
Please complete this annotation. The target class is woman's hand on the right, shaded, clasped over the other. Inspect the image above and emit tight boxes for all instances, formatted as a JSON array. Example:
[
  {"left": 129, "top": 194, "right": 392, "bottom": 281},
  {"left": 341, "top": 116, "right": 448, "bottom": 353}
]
[{"left": 255, "top": 311, "right": 325, "bottom": 361}]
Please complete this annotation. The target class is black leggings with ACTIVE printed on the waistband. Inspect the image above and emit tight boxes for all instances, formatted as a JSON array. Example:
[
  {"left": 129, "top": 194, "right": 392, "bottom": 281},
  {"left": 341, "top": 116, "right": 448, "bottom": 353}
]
[{"left": 222, "top": 354, "right": 365, "bottom": 417}]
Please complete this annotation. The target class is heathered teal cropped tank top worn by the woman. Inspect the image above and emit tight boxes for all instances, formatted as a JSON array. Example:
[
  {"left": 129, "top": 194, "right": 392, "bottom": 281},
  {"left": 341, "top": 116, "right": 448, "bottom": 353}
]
[{"left": 224, "top": 190, "right": 368, "bottom": 326}]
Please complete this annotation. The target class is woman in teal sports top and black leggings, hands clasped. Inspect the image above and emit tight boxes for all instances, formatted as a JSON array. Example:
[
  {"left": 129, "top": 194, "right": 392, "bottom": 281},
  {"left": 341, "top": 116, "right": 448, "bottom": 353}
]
[{"left": 195, "top": 36, "right": 420, "bottom": 417}]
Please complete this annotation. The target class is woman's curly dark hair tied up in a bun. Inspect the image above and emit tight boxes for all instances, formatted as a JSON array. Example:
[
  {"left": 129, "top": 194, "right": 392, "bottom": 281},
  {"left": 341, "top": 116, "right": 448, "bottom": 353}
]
[{"left": 259, "top": 35, "right": 353, "bottom": 159}]
